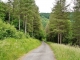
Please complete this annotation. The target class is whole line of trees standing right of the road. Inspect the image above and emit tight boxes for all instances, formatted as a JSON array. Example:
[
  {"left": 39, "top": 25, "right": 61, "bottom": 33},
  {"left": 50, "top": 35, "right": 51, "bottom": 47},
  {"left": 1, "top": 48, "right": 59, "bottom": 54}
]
[{"left": 46, "top": 0, "right": 80, "bottom": 45}]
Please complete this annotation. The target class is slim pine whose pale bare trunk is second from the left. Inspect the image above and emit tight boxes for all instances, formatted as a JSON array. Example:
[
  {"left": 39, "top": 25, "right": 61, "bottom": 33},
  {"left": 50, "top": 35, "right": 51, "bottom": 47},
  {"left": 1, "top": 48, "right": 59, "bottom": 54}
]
[{"left": 13, "top": 0, "right": 21, "bottom": 30}]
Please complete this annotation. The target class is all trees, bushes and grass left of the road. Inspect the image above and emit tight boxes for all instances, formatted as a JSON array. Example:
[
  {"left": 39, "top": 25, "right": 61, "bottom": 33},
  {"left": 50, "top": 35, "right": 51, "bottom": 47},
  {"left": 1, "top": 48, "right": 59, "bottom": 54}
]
[{"left": 0, "top": 0, "right": 43, "bottom": 60}]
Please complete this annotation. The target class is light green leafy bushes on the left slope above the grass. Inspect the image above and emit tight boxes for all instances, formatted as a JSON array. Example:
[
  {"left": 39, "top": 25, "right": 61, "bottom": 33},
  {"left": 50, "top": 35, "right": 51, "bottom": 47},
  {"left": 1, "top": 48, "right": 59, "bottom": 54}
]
[{"left": 0, "top": 20, "right": 25, "bottom": 39}]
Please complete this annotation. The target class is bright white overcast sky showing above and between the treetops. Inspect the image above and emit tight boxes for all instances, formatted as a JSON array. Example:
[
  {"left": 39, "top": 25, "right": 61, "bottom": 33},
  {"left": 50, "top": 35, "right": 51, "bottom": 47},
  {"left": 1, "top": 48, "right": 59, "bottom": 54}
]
[{"left": 3, "top": 0, "right": 74, "bottom": 13}]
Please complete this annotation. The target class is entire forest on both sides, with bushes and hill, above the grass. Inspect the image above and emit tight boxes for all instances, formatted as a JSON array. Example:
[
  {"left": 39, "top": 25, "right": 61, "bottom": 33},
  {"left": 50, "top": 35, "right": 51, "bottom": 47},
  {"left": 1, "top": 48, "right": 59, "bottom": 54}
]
[{"left": 0, "top": 0, "right": 80, "bottom": 45}]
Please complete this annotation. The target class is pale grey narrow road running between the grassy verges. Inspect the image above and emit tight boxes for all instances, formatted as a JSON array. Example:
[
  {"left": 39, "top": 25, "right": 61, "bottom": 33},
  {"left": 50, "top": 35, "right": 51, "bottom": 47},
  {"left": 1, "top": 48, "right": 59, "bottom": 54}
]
[{"left": 18, "top": 42, "right": 56, "bottom": 60}]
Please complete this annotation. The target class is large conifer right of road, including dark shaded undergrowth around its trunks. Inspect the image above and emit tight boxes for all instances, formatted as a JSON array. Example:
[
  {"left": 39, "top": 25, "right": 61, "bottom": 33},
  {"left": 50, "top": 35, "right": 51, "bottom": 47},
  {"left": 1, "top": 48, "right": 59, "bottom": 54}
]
[{"left": 46, "top": 0, "right": 71, "bottom": 43}]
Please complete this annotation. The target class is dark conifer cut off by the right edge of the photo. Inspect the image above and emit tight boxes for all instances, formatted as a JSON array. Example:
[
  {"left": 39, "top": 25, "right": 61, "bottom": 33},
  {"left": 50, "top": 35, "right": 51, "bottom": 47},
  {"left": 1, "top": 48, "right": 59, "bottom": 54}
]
[{"left": 73, "top": 0, "right": 80, "bottom": 45}]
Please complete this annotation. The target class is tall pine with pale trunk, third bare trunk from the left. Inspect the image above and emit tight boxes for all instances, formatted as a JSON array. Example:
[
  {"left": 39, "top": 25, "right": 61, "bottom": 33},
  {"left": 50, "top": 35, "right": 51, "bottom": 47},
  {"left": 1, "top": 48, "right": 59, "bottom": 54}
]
[{"left": 21, "top": 0, "right": 34, "bottom": 34}]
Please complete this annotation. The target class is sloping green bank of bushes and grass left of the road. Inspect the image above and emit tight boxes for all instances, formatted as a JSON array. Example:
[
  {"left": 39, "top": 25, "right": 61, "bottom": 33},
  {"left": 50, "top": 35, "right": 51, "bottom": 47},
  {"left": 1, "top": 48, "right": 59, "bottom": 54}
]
[{"left": 0, "top": 16, "right": 41, "bottom": 60}]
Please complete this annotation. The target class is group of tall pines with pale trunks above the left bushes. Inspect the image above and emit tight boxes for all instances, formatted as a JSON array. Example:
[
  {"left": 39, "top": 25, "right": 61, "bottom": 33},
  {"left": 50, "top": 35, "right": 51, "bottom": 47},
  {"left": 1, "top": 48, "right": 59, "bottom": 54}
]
[{"left": 12, "top": 0, "right": 41, "bottom": 38}]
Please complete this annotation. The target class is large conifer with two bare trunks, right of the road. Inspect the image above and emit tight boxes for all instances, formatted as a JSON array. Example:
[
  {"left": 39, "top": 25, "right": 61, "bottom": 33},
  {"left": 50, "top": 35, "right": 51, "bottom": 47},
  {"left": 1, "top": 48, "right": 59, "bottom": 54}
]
[{"left": 49, "top": 0, "right": 68, "bottom": 44}]
